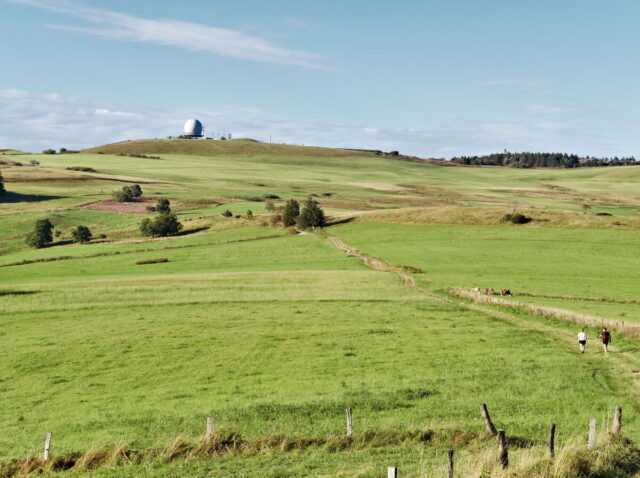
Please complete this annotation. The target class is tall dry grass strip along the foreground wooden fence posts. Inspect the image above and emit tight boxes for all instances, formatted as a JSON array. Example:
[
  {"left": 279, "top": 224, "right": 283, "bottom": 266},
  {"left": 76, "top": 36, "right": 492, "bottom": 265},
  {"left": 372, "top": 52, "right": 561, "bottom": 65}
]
[{"left": 0, "top": 429, "right": 640, "bottom": 478}]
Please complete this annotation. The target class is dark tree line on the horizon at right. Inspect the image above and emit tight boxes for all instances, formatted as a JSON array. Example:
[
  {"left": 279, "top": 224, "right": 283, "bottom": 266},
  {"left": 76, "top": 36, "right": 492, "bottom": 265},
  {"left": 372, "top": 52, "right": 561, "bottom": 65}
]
[{"left": 451, "top": 151, "right": 640, "bottom": 168}]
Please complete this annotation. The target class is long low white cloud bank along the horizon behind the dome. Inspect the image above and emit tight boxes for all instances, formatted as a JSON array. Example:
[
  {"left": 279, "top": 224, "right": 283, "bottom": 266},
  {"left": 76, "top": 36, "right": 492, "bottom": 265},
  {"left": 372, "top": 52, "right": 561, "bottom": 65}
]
[{"left": 0, "top": 89, "right": 634, "bottom": 158}]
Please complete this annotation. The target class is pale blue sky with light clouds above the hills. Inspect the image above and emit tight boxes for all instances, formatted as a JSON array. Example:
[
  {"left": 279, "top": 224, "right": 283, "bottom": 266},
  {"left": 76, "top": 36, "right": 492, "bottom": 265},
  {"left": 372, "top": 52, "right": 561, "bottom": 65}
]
[{"left": 0, "top": 0, "right": 640, "bottom": 157}]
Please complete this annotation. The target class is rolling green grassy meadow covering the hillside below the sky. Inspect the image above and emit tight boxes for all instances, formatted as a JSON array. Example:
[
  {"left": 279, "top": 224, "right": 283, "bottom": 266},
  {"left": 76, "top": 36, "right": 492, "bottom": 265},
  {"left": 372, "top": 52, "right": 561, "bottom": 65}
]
[{"left": 0, "top": 140, "right": 640, "bottom": 478}]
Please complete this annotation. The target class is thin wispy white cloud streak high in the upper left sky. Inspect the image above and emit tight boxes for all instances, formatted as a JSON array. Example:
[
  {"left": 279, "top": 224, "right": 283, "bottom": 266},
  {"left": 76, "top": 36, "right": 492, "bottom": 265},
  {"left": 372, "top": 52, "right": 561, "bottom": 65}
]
[{"left": 5, "top": 0, "right": 328, "bottom": 69}]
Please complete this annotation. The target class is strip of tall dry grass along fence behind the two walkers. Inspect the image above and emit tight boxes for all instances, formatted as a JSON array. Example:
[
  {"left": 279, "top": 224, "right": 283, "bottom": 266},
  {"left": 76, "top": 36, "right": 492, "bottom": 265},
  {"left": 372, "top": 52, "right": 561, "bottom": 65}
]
[{"left": 447, "top": 287, "right": 640, "bottom": 339}]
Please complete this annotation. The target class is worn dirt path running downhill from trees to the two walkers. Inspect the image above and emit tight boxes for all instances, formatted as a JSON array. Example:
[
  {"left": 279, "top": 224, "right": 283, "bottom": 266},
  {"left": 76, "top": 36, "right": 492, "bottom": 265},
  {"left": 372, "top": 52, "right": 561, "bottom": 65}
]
[{"left": 328, "top": 236, "right": 640, "bottom": 392}]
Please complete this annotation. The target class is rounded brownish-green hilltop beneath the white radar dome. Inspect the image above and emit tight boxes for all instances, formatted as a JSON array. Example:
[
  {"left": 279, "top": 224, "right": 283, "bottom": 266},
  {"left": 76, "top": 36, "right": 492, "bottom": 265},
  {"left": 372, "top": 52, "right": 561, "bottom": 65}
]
[{"left": 83, "top": 139, "right": 373, "bottom": 157}]
